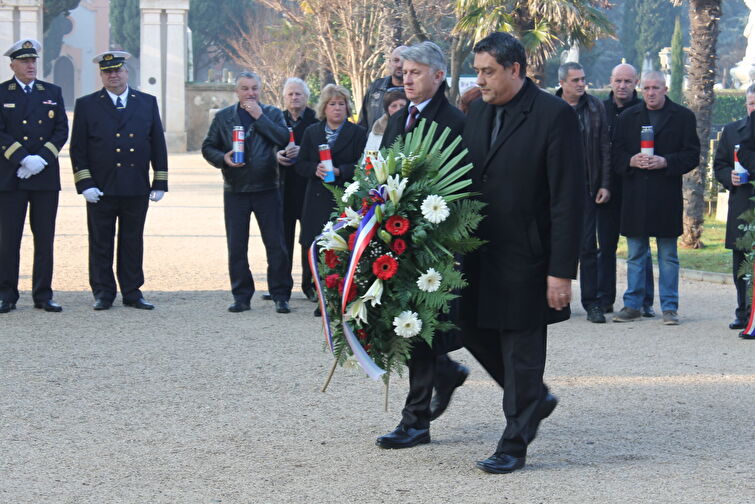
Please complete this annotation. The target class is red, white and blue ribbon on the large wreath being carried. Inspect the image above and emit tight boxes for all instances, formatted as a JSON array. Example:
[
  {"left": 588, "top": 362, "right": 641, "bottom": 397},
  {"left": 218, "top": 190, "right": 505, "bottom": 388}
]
[{"left": 308, "top": 199, "right": 385, "bottom": 380}]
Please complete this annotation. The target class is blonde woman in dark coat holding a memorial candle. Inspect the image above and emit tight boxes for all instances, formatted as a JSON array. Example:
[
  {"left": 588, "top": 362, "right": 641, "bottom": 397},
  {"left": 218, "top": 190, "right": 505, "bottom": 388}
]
[{"left": 295, "top": 84, "right": 367, "bottom": 315}]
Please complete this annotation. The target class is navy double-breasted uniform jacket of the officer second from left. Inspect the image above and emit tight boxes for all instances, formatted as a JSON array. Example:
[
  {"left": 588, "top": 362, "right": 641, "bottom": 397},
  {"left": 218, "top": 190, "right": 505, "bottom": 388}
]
[{"left": 71, "top": 88, "right": 168, "bottom": 196}]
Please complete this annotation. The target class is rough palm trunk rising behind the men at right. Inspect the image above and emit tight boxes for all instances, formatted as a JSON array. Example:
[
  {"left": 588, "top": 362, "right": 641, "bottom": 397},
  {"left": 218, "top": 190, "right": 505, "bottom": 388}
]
[{"left": 681, "top": 0, "right": 721, "bottom": 248}]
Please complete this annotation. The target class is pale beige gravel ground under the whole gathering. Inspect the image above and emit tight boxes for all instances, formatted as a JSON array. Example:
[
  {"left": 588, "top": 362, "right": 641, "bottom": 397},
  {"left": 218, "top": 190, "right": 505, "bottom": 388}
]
[{"left": 0, "top": 154, "right": 755, "bottom": 504}]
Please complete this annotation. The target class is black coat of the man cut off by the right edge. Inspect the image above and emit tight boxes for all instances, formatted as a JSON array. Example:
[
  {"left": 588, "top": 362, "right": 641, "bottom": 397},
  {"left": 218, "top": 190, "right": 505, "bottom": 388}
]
[{"left": 713, "top": 117, "right": 755, "bottom": 249}]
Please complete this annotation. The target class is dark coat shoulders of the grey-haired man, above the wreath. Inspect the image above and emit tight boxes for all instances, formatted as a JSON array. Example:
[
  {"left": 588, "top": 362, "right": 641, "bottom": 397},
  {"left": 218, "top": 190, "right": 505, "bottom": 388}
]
[{"left": 380, "top": 82, "right": 466, "bottom": 150}]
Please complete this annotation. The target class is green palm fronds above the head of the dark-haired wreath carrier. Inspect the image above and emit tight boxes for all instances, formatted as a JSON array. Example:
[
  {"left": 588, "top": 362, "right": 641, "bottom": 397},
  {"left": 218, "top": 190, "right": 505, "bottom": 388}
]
[{"left": 455, "top": 0, "right": 614, "bottom": 84}]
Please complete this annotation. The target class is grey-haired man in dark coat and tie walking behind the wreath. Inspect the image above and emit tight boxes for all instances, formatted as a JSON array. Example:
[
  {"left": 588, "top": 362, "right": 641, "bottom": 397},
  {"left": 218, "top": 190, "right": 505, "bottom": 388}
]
[{"left": 377, "top": 42, "right": 469, "bottom": 448}]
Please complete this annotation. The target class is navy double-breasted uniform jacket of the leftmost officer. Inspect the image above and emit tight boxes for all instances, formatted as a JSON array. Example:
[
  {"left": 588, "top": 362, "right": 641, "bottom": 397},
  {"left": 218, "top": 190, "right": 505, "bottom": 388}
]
[{"left": 0, "top": 78, "right": 68, "bottom": 191}]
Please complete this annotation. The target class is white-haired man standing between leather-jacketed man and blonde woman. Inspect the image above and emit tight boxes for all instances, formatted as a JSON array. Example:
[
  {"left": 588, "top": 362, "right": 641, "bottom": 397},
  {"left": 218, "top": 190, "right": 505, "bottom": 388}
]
[{"left": 276, "top": 77, "right": 317, "bottom": 302}]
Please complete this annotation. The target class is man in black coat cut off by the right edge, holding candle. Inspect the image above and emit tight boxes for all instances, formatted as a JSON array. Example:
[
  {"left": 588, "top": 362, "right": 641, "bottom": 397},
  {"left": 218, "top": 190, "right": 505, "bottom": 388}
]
[{"left": 713, "top": 84, "right": 755, "bottom": 329}]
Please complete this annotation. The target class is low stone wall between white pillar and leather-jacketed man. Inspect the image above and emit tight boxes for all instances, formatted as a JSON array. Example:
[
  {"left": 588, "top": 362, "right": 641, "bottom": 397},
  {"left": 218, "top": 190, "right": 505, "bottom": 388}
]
[{"left": 186, "top": 82, "right": 237, "bottom": 151}]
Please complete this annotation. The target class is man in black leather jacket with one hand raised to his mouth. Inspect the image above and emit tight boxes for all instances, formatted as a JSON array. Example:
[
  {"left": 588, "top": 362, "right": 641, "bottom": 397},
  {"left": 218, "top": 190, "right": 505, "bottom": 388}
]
[{"left": 202, "top": 72, "right": 293, "bottom": 313}]
